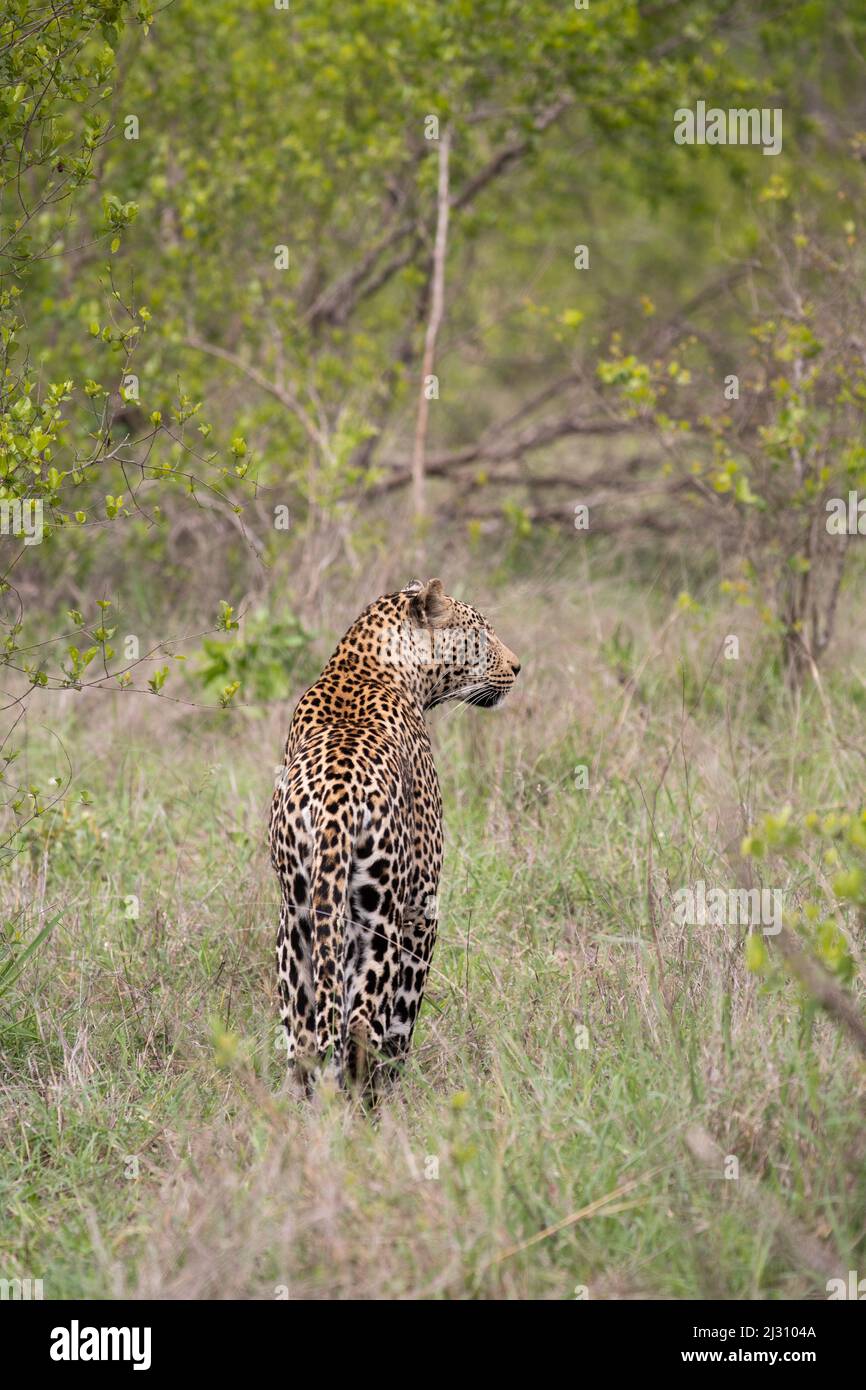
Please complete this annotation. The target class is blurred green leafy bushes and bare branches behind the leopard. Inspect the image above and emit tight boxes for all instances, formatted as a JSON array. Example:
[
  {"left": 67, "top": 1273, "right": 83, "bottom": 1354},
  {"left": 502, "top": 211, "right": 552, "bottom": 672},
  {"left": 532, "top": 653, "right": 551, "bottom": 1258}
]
[{"left": 0, "top": 0, "right": 866, "bottom": 684}]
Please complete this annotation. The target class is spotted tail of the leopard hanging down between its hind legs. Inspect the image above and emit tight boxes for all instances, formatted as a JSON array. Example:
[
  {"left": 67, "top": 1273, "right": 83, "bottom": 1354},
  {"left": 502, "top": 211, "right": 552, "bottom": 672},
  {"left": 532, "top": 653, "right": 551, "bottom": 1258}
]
[{"left": 310, "top": 828, "right": 352, "bottom": 1080}]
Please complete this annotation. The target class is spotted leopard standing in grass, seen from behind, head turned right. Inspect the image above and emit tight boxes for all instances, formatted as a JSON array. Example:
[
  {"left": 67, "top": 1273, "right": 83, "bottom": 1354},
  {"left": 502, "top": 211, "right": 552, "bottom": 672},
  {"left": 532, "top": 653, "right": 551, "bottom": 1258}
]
[{"left": 270, "top": 578, "right": 520, "bottom": 1095}]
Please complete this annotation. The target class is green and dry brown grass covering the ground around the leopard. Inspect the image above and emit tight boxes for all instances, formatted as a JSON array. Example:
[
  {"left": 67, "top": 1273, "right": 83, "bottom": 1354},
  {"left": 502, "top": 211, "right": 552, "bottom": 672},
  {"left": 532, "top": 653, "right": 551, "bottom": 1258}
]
[{"left": 0, "top": 572, "right": 866, "bottom": 1298}]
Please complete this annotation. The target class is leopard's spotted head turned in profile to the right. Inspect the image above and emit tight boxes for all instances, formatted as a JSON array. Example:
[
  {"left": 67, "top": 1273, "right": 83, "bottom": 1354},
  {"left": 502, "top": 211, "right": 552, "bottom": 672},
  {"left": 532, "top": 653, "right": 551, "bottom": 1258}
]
[{"left": 393, "top": 580, "right": 520, "bottom": 709}]
